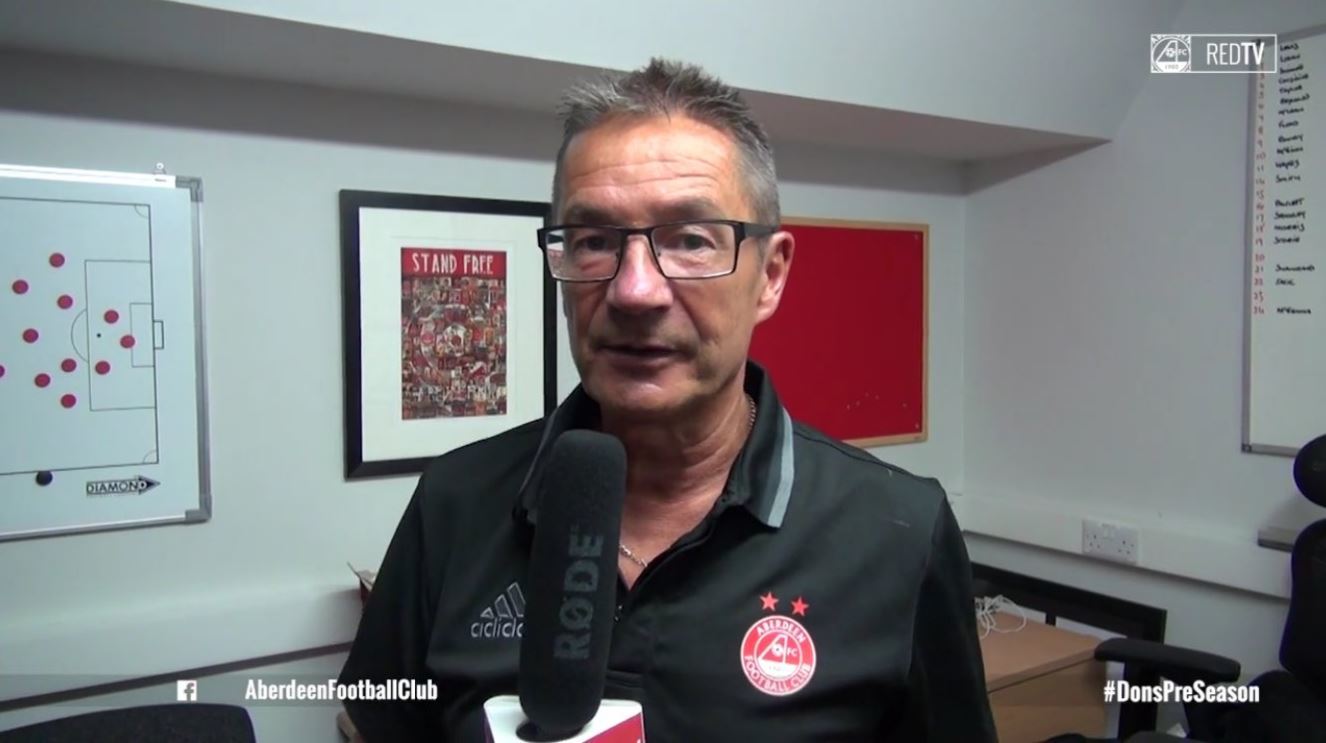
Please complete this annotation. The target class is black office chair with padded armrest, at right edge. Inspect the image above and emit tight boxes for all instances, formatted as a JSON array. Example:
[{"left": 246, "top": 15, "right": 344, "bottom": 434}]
[{"left": 1052, "top": 435, "right": 1326, "bottom": 743}]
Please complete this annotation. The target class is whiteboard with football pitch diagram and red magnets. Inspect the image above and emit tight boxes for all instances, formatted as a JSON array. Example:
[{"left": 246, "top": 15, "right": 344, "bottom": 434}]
[{"left": 0, "top": 166, "right": 211, "bottom": 539}]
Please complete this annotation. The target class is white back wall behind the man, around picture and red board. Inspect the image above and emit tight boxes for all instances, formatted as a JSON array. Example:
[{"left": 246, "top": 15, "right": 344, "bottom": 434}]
[{"left": 0, "top": 52, "right": 964, "bottom": 740}]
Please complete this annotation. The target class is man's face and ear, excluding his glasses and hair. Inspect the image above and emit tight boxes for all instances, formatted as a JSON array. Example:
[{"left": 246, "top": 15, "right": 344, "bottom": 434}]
[{"left": 557, "top": 115, "right": 793, "bottom": 417}]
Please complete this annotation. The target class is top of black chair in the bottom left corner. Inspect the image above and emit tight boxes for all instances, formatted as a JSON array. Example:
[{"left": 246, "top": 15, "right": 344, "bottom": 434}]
[{"left": 0, "top": 702, "right": 257, "bottom": 743}]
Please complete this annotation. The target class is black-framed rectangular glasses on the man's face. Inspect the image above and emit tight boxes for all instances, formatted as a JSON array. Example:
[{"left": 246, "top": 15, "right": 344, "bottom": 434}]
[{"left": 538, "top": 219, "right": 778, "bottom": 281}]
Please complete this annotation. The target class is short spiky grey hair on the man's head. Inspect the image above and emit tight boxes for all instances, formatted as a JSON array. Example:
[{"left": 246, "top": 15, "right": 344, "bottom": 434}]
[{"left": 553, "top": 57, "right": 780, "bottom": 225}]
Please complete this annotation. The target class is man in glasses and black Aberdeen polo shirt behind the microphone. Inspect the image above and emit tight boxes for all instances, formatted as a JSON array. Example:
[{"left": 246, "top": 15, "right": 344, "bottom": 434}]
[{"left": 342, "top": 60, "right": 995, "bottom": 743}]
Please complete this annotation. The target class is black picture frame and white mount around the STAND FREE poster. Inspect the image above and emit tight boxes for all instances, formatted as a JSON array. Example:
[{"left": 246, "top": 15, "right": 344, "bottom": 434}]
[{"left": 339, "top": 190, "right": 557, "bottom": 479}]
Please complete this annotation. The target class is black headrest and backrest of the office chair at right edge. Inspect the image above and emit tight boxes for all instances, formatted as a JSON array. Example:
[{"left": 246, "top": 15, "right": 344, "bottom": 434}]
[{"left": 1280, "top": 437, "right": 1326, "bottom": 699}]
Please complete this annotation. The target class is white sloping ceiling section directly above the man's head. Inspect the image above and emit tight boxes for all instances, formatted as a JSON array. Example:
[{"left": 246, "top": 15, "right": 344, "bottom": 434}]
[{"left": 165, "top": 0, "right": 1179, "bottom": 137}]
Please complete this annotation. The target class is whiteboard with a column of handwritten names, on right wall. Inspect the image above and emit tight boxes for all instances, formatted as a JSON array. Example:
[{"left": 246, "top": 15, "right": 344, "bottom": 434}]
[{"left": 1242, "top": 27, "right": 1326, "bottom": 455}]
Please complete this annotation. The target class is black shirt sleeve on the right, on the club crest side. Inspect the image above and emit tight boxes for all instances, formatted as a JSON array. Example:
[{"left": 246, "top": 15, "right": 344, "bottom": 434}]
[{"left": 896, "top": 499, "right": 996, "bottom": 743}]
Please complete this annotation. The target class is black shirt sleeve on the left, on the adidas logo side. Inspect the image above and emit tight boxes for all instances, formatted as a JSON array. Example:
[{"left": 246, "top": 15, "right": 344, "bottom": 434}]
[{"left": 339, "top": 476, "right": 446, "bottom": 743}]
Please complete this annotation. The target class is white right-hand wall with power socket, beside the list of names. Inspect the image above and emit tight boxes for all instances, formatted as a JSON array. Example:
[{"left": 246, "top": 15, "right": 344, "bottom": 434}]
[{"left": 961, "top": 3, "right": 1326, "bottom": 673}]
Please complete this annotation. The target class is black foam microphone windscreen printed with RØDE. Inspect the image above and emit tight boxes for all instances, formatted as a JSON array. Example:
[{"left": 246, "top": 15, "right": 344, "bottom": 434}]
[{"left": 517, "top": 430, "right": 626, "bottom": 740}]
